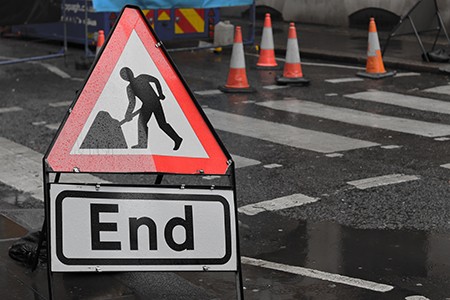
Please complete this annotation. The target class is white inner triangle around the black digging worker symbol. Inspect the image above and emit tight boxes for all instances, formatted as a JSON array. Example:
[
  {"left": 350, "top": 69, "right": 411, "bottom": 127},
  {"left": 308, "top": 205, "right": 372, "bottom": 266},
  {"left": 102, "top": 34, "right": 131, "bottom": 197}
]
[{"left": 71, "top": 31, "right": 208, "bottom": 158}]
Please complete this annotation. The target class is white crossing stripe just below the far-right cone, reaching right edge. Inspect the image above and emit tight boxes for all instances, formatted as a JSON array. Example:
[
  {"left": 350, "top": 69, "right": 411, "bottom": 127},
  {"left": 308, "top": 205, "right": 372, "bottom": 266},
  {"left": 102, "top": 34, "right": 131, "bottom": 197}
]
[{"left": 344, "top": 91, "right": 450, "bottom": 114}]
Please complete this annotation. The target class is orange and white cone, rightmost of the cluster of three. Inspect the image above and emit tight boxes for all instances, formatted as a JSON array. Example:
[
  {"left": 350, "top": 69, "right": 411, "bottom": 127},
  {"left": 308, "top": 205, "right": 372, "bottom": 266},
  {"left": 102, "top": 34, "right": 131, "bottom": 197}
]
[{"left": 276, "top": 23, "right": 309, "bottom": 85}]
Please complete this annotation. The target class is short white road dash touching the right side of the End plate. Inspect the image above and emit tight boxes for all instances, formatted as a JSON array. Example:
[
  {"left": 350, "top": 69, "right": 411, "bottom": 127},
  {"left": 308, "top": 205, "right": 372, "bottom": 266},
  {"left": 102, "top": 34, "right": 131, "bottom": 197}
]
[{"left": 238, "top": 194, "right": 319, "bottom": 216}]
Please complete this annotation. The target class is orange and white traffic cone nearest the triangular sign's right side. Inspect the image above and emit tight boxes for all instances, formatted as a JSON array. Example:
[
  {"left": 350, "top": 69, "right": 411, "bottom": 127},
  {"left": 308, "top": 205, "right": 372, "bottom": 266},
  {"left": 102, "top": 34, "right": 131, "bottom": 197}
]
[{"left": 219, "top": 26, "right": 255, "bottom": 93}]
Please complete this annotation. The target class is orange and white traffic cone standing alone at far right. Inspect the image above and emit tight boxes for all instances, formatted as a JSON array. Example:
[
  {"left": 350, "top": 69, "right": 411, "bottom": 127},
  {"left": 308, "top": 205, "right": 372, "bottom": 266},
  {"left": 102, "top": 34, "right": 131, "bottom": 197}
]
[{"left": 356, "top": 18, "right": 396, "bottom": 79}]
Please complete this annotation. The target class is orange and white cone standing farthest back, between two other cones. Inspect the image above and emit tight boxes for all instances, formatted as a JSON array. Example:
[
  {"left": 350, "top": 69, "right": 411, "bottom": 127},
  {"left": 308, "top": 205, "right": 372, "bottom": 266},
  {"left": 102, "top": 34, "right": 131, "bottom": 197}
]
[{"left": 256, "top": 13, "right": 278, "bottom": 69}]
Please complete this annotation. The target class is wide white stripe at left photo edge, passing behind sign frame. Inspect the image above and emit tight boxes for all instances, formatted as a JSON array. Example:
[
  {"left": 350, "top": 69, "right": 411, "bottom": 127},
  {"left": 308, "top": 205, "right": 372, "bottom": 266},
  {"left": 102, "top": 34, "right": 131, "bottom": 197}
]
[{"left": 0, "top": 137, "right": 105, "bottom": 201}]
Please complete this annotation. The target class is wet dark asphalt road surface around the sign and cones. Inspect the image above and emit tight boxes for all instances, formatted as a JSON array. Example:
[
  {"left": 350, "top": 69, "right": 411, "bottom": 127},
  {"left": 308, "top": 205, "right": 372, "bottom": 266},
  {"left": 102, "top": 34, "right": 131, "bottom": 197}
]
[{"left": 0, "top": 36, "right": 450, "bottom": 299}]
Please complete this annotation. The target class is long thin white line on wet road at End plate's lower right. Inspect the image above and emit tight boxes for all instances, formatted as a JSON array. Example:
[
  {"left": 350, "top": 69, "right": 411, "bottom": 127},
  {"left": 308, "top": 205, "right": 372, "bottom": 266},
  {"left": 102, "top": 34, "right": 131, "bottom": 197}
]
[{"left": 241, "top": 256, "right": 394, "bottom": 293}]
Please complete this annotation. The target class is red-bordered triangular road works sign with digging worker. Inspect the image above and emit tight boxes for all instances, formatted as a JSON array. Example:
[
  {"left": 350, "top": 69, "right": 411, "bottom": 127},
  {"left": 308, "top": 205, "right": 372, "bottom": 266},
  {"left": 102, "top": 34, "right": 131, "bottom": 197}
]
[{"left": 45, "top": 6, "right": 231, "bottom": 175}]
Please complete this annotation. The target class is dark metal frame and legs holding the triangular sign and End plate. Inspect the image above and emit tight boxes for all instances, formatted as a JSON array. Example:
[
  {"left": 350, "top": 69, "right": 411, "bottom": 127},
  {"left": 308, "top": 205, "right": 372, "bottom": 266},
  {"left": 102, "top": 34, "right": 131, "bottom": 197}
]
[{"left": 37, "top": 6, "right": 244, "bottom": 300}]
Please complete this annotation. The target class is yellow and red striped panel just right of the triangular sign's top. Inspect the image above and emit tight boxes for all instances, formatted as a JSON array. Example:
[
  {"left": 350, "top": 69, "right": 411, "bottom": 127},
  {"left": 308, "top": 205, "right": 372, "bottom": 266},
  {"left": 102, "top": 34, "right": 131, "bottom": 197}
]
[{"left": 175, "top": 8, "right": 205, "bottom": 34}]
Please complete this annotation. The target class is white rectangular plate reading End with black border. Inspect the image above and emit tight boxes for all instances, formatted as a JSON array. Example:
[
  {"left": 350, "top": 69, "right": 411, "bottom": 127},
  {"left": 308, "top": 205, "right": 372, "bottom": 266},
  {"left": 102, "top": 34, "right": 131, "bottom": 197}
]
[{"left": 50, "top": 184, "right": 237, "bottom": 272}]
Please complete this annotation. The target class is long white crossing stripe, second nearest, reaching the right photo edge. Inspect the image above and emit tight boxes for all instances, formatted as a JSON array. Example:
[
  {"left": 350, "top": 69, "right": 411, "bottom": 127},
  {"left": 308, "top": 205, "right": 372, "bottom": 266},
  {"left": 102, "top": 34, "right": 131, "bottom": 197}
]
[{"left": 256, "top": 100, "right": 450, "bottom": 137}]
